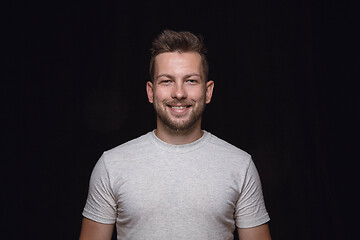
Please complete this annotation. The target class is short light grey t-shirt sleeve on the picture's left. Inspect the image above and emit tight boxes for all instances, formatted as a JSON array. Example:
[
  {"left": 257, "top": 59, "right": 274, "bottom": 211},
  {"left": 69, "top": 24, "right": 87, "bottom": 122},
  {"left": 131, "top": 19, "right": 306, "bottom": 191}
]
[{"left": 82, "top": 155, "right": 116, "bottom": 224}]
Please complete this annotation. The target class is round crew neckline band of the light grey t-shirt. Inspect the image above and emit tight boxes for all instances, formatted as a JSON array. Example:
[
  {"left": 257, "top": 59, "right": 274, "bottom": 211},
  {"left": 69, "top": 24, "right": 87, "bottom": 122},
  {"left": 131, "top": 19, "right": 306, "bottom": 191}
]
[{"left": 148, "top": 130, "right": 211, "bottom": 153}]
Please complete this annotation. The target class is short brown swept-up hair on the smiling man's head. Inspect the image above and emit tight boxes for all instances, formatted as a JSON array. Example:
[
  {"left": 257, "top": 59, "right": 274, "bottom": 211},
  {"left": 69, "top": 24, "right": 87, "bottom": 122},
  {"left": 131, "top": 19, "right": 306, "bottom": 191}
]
[{"left": 149, "top": 30, "right": 209, "bottom": 82}]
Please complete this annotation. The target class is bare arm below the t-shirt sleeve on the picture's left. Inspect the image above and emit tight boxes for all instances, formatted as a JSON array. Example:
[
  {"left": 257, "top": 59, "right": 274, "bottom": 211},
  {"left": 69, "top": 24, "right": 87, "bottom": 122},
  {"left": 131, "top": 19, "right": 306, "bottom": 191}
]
[{"left": 79, "top": 218, "right": 114, "bottom": 240}]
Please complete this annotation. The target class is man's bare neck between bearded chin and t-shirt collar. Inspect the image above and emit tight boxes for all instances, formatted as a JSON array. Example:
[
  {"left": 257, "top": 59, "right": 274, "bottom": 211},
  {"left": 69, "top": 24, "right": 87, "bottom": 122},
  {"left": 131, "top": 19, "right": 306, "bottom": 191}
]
[{"left": 155, "top": 122, "right": 204, "bottom": 145}]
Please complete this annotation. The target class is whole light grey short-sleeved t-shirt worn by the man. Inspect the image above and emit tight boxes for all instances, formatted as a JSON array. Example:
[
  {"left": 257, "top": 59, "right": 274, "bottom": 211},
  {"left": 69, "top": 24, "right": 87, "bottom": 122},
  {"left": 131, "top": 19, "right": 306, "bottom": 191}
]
[{"left": 83, "top": 131, "right": 270, "bottom": 240}]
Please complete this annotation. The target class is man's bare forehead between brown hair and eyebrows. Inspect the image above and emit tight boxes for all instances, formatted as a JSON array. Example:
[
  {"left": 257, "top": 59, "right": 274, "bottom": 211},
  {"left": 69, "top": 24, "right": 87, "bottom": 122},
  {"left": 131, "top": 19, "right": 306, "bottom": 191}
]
[{"left": 155, "top": 52, "right": 202, "bottom": 75}]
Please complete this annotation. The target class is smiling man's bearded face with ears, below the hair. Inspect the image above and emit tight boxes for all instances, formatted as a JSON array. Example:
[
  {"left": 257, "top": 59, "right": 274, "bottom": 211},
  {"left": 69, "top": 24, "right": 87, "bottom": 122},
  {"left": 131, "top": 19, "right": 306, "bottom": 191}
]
[{"left": 147, "top": 52, "right": 214, "bottom": 132}]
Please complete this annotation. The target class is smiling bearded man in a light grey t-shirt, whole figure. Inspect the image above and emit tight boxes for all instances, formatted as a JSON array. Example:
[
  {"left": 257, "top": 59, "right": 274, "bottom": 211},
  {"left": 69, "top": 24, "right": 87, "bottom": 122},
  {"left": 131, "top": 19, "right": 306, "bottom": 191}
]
[{"left": 80, "top": 30, "right": 270, "bottom": 240}]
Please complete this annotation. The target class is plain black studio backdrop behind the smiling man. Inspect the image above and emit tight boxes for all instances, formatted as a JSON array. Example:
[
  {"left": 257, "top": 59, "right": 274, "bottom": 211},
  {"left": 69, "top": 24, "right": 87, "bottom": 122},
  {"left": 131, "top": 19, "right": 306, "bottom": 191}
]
[{"left": 1, "top": 0, "right": 359, "bottom": 239}]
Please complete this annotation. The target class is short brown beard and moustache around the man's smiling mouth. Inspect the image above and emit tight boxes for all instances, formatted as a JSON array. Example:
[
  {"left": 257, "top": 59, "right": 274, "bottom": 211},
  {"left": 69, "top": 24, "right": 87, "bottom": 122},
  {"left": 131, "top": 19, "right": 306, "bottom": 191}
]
[{"left": 154, "top": 99, "right": 206, "bottom": 133}]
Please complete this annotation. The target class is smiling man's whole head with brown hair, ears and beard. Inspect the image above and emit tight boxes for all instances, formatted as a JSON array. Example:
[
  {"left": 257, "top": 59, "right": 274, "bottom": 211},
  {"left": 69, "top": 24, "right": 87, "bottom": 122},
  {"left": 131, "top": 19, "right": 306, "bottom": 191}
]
[{"left": 146, "top": 31, "right": 214, "bottom": 133}]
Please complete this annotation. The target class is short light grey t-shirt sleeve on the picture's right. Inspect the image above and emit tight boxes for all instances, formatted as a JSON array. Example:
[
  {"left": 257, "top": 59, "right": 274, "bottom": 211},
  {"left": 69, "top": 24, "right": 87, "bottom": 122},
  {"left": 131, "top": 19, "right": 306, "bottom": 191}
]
[{"left": 235, "top": 159, "right": 270, "bottom": 228}]
